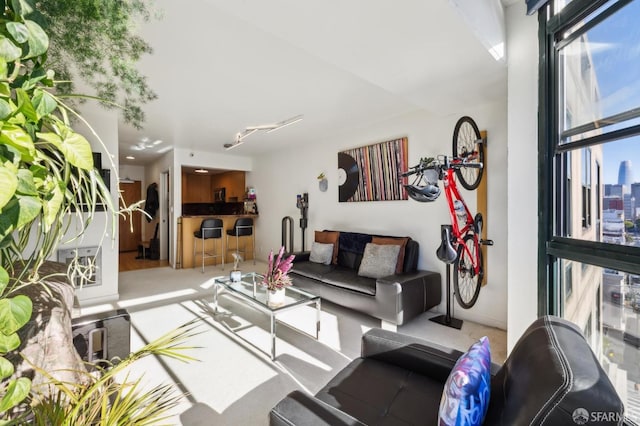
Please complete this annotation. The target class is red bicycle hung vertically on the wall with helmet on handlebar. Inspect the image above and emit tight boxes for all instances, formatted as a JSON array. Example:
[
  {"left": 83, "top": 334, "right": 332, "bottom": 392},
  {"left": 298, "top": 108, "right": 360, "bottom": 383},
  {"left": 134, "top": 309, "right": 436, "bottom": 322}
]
[{"left": 401, "top": 117, "right": 493, "bottom": 328}]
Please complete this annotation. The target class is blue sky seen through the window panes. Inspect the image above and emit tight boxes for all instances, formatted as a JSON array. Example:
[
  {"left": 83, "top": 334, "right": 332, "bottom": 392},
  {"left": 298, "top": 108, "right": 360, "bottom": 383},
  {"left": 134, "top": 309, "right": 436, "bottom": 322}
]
[{"left": 587, "top": 1, "right": 640, "bottom": 184}]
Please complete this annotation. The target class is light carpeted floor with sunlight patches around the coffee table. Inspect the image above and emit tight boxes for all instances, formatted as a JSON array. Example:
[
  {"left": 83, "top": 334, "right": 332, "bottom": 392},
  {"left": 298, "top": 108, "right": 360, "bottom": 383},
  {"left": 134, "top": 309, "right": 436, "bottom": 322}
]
[{"left": 79, "top": 262, "right": 506, "bottom": 426}]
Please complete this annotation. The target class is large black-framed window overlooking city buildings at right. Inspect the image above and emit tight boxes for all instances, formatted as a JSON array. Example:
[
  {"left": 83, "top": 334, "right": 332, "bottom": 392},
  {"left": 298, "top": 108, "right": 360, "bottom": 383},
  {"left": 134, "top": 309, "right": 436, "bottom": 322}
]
[{"left": 539, "top": 0, "right": 640, "bottom": 423}]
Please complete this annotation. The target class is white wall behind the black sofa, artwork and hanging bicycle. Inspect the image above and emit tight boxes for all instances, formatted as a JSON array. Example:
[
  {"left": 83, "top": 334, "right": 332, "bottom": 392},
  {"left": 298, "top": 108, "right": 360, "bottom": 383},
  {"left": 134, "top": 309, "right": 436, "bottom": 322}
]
[{"left": 247, "top": 102, "right": 507, "bottom": 329}]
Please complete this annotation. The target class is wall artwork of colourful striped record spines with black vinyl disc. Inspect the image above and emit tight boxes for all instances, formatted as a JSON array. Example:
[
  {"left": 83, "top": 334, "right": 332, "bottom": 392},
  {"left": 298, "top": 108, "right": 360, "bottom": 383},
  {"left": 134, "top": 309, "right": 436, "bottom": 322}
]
[{"left": 338, "top": 137, "right": 408, "bottom": 202}]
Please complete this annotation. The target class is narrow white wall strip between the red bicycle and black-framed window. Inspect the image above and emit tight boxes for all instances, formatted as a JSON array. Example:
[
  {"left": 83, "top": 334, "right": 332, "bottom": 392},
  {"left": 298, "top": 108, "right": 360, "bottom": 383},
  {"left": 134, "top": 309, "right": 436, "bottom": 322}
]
[{"left": 506, "top": 2, "right": 538, "bottom": 351}]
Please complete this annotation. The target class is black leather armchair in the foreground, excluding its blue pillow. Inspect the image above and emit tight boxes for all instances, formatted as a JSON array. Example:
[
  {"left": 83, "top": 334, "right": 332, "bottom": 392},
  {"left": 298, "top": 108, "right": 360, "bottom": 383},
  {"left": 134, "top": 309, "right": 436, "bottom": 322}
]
[{"left": 270, "top": 316, "right": 624, "bottom": 426}]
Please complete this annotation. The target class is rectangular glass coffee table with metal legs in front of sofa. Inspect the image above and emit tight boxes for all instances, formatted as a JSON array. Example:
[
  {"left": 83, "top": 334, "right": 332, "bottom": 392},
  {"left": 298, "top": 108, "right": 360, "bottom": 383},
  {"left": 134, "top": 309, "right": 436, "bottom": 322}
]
[{"left": 213, "top": 272, "right": 320, "bottom": 360}]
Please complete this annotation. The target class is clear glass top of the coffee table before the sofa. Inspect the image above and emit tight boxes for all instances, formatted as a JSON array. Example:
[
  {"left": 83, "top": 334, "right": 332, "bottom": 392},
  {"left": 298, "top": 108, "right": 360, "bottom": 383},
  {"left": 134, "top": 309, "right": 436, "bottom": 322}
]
[{"left": 215, "top": 272, "right": 318, "bottom": 311}]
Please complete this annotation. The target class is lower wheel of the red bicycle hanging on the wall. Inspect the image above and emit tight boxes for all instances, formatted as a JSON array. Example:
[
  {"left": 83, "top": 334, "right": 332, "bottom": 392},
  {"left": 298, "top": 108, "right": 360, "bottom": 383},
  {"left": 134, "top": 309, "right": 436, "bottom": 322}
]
[{"left": 453, "top": 232, "right": 484, "bottom": 309}]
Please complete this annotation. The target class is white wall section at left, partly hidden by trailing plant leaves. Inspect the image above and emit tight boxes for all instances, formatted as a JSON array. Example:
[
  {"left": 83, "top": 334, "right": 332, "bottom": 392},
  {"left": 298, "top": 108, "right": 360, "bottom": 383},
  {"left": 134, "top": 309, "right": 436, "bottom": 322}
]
[{"left": 58, "top": 103, "right": 118, "bottom": 305}]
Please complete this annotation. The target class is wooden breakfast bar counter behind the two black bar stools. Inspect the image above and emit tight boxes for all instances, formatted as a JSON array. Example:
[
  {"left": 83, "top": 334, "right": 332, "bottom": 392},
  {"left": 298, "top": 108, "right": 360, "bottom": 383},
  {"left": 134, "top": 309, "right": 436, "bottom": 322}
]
[{"left": 180, "top": 214, "right": 258, "bottom": 269}]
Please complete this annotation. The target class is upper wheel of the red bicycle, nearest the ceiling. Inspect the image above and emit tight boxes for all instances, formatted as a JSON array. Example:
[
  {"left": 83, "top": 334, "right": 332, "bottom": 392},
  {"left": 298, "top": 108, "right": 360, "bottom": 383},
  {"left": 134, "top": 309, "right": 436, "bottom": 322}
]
[{"left": 453, "top": 116, "right": 484, "bottom": 190}]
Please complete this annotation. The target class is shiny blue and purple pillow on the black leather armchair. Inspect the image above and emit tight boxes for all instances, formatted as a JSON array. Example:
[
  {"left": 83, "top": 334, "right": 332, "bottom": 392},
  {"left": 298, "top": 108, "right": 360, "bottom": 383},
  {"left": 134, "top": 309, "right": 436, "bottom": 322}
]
[{"left": 438, "top": 336, "right": 491, "bottom": 426}]
